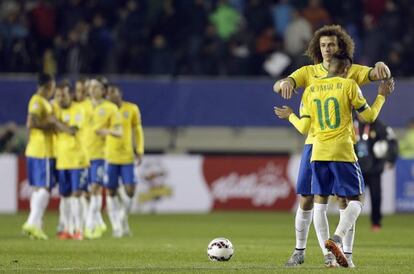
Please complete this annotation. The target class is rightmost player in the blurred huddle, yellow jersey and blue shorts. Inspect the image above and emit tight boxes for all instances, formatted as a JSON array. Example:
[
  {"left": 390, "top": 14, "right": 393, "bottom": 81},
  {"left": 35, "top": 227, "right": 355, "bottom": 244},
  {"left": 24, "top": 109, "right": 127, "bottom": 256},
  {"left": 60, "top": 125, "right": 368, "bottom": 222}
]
[{"left": 105, "top": 85, "right": 144, "bottom": 237}]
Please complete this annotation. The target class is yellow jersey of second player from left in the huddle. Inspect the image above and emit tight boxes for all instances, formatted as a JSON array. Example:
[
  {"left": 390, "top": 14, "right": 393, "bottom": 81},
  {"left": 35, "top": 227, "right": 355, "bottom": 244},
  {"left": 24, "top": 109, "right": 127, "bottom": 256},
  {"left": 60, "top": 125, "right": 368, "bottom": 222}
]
[{"left": 56, "top": 103, "right": 89, "bottom": 169}]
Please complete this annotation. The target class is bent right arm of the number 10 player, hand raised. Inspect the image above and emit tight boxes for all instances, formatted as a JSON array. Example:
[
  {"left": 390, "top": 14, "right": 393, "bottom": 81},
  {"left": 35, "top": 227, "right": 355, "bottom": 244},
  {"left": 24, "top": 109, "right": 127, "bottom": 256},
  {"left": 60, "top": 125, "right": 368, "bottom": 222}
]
[{"left": 353, "top": 79, "right": 394, "bottom": 123}]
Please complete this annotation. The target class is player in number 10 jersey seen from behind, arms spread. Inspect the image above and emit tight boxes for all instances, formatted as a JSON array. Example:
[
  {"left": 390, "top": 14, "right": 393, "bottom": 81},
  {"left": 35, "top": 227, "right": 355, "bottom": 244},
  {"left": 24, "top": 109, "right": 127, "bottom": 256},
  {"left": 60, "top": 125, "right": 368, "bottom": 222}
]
[{"left": 275, "top": 53, "right": 394, "bottom": 267}]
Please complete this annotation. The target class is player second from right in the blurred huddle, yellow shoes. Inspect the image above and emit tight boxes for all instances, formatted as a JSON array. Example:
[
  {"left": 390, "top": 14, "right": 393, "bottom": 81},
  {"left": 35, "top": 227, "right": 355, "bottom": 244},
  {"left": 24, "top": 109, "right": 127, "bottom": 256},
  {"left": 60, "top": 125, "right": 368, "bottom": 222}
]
[{"left": 84, "top": 79, "right": 122, "bottom": 239}]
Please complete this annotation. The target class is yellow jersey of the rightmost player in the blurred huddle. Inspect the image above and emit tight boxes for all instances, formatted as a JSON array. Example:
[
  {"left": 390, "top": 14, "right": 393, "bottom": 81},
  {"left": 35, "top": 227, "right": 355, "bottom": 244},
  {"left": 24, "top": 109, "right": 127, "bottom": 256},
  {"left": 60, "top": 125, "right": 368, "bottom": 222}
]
[{"left": 105, "top": 101, "right": 144, "bottom": 164}]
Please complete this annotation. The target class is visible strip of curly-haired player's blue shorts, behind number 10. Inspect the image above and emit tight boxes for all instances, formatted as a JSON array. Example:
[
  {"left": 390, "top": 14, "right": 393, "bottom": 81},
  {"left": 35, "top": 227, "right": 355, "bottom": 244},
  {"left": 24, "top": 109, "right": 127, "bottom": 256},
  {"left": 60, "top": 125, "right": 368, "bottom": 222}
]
[{"left": 296, "top": 144, "right": 312, "bottom": 195}]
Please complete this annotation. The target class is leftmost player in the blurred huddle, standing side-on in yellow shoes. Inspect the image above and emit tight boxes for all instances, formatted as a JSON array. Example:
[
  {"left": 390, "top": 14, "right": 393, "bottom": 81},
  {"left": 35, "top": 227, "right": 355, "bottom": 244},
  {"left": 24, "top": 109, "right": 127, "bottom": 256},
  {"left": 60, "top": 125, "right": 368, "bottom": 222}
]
[{"left": 22, "top": 74, "right": 56, "bottom": 240}]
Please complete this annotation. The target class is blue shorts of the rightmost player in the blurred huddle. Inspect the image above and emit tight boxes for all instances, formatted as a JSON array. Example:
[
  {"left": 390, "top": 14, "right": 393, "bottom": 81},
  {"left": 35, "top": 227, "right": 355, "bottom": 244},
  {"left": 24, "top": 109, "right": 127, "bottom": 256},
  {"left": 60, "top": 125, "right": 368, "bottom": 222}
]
[{"left": 105, "top": 163, "right": 135, "bottom": 189}]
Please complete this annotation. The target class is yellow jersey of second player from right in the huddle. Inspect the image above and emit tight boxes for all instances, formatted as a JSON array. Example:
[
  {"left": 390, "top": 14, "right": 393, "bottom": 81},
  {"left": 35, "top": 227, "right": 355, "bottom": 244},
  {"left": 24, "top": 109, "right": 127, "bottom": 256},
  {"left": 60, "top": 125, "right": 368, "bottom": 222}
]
[{"left": 86, "top": 100, "right": 120, "bottom": 160}]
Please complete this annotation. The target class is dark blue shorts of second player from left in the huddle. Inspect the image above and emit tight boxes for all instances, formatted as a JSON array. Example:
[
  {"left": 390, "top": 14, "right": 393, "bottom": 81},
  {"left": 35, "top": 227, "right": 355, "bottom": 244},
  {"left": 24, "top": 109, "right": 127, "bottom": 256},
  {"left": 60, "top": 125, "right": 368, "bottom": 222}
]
[{"left": 59, "top": 168, "right": 88, "bottom": 197}]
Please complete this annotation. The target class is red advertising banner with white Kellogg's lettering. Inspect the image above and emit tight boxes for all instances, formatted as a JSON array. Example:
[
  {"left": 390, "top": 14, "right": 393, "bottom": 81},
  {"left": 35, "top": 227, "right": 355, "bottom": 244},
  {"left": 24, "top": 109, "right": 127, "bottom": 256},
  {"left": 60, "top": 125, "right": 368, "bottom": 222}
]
[{"left": 203, "top": 156, "right": 296, "bottom": 211}]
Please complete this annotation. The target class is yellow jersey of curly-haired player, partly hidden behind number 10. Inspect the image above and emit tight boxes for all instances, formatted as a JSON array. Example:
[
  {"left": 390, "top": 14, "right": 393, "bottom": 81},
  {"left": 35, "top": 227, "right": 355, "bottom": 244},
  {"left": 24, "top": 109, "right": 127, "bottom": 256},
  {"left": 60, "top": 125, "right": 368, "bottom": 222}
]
[{"left": 288, "top": 63, "right": 372, "bottom": 144}]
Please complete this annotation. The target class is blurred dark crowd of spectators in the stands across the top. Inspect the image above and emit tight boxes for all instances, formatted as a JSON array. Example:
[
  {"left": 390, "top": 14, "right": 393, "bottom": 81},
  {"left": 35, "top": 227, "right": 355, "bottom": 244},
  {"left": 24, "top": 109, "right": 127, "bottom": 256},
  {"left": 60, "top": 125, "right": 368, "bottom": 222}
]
[{"left": 0, "top": 0, "right": 414, "bottom": 77}]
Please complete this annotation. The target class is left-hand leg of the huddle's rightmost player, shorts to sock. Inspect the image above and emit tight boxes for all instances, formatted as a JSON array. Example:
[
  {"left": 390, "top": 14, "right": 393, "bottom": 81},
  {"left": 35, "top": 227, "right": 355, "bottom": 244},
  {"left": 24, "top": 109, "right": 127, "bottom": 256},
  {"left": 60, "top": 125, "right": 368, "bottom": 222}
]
[{"left": 105, "top": 163, "right": 123, "bottom": 238}]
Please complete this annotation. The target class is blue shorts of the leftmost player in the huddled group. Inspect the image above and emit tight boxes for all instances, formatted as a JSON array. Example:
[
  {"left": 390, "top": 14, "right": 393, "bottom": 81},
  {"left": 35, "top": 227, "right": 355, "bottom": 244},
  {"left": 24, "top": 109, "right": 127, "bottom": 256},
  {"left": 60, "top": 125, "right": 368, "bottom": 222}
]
[{"left": 26, "top": 157, "right": 56, "bottom": 189}]
